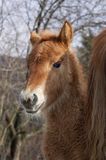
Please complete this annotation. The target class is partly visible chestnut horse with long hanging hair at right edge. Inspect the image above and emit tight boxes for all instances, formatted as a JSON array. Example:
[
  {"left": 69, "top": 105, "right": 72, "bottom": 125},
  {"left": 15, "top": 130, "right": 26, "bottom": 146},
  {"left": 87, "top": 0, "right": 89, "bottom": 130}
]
[{"left": 87, "top": 30, "right": 106, "bottom": 160}]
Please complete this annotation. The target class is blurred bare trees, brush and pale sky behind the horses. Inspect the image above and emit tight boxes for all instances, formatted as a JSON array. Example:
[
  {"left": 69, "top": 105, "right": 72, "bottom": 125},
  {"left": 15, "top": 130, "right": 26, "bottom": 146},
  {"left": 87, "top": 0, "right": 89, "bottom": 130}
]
[{"left": 0, "top": 0, "right": 106, "bottom": 160}]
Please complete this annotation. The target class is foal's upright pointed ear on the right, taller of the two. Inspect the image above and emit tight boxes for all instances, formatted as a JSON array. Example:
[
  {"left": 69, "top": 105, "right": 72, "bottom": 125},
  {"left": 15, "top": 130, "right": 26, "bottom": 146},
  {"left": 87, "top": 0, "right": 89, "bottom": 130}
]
[{"left": 59, "top": 21, "right": 73, "bottom": 46}]
